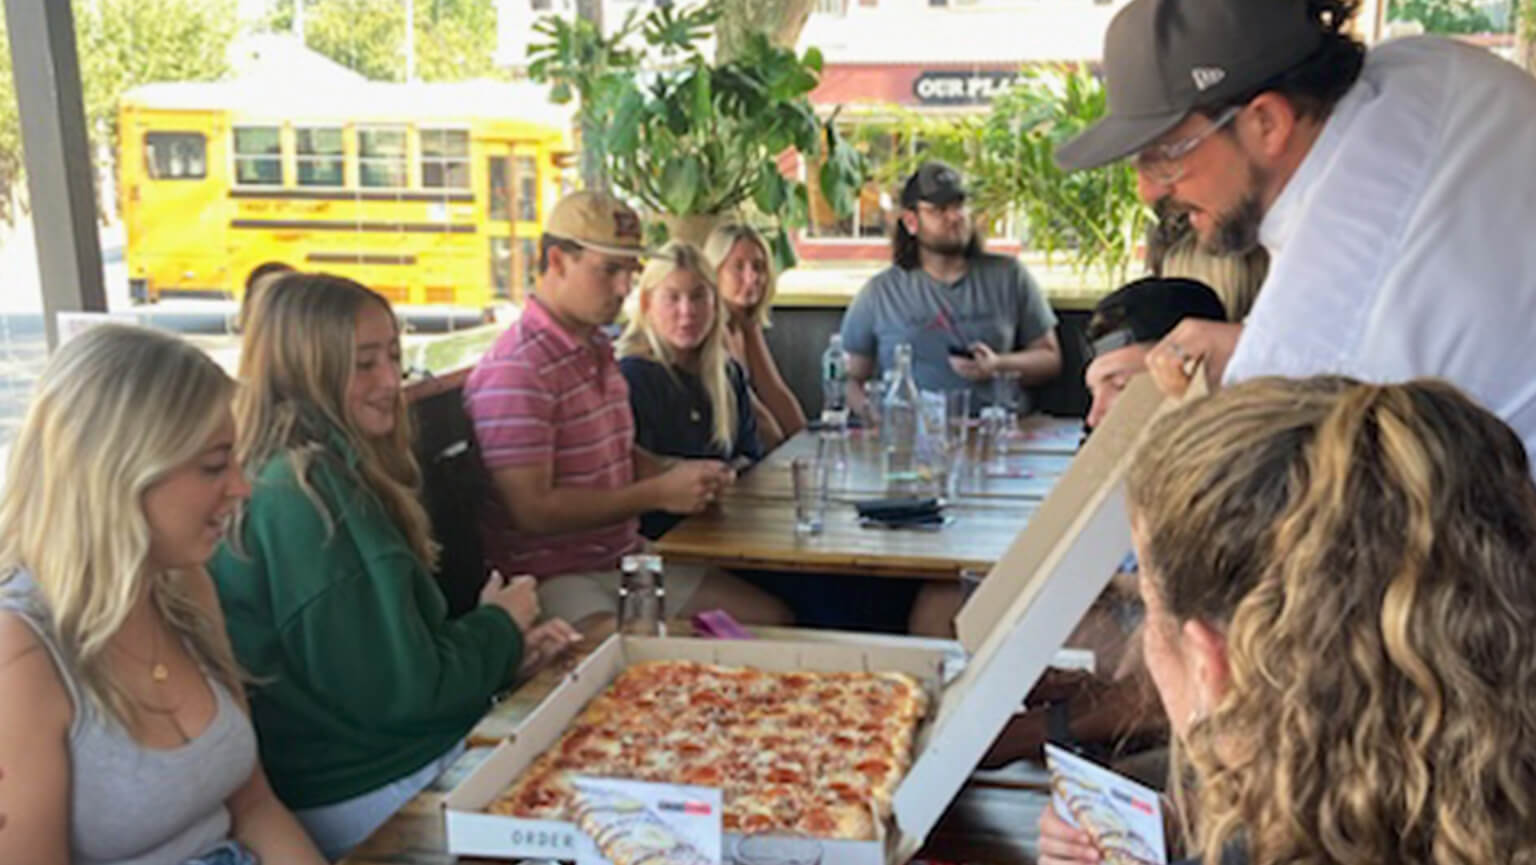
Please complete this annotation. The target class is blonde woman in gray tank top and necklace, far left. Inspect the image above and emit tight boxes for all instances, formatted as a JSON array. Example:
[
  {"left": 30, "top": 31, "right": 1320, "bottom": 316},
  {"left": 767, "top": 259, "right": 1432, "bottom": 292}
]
[{"left": 0, "top": 324, "right": 321, "bottom": 865}]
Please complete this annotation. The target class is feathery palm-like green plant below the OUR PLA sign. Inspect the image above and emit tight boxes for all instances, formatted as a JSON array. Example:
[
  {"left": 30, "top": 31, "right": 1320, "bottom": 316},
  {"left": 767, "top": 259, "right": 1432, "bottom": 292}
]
[{"left": 869, "top": 66, "right": 1152, "bottom": 287}]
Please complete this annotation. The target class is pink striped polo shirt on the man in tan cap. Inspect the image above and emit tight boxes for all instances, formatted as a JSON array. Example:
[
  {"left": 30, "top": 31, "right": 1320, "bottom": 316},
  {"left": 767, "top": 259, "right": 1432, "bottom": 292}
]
[{"left": 464, "top": 300, "right": 641, "bottom": 578}]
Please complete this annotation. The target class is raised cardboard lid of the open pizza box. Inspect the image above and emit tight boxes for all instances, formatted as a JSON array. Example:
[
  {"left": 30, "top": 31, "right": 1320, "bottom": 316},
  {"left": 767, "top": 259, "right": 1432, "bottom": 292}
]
[{"left": 894, "top": 375, "right": 1167, "bottom": 860}]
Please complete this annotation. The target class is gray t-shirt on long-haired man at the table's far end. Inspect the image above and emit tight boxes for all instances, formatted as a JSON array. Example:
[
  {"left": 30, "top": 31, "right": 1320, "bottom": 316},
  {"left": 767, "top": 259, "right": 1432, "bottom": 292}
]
[{"left": 842, "top": 254, "right": 1057, "bottom": 412}]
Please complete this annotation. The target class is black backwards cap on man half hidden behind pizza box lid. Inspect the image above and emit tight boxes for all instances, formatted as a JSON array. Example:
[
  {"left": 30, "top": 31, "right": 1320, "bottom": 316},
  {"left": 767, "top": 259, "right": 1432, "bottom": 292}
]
[{"left": 1087, "top": 277, "right": 1227, "bottom": 356}]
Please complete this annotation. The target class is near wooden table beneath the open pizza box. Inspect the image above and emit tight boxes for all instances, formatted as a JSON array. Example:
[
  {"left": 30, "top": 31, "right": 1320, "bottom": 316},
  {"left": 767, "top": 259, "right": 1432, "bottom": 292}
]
[{"left": 341, "top": 624, "right": 1049, "bottom": 865}]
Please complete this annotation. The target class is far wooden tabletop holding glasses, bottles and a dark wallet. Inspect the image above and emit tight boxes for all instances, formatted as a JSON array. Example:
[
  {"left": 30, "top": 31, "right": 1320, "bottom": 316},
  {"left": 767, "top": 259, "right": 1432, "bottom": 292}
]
[{"left": 656, "top": 418, "right": 1081, "bottom": 579}]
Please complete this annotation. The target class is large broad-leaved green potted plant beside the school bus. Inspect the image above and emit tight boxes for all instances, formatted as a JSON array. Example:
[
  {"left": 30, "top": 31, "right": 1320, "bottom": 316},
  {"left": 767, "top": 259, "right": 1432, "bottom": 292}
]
[{"left": 528, "top": 3, "right": 865, "bottom": 266}]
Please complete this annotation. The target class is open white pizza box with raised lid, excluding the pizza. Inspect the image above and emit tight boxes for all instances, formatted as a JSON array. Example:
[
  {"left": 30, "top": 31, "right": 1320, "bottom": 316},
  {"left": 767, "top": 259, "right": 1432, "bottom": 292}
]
[{"left": 444, "top": 376, "right": 1164, "bottom": 865}]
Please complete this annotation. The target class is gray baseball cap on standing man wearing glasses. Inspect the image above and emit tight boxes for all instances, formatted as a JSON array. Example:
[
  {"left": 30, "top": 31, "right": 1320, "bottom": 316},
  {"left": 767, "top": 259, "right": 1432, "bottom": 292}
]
[{"left": 1055, "top": 0, "right": 1322, "bottom": 171}]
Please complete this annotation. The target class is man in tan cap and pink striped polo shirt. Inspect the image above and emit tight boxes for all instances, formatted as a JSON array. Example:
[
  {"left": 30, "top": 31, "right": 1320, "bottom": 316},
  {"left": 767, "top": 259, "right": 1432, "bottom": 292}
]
[{"left": 464, "top": 192, "right": 788, "bottom": 631}]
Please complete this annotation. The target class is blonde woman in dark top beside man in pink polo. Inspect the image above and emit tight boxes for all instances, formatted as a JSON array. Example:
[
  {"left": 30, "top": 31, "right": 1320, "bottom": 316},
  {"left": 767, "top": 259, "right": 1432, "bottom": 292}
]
[{"left": 616, "top": 241, "right": 762, "bottom": 539}]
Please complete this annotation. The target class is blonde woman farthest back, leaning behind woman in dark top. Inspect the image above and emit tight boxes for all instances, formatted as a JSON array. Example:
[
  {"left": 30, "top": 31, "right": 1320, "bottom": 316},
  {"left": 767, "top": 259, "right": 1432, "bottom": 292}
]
[{"left": 703, "top": 223, "right": 805, "bottom": 450}]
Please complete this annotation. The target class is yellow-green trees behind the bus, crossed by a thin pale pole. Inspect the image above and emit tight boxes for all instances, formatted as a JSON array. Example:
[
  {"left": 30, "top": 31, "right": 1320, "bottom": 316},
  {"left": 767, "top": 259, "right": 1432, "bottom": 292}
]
[{"left": 267, "top": 0, "right": 499, "bottom": 81}]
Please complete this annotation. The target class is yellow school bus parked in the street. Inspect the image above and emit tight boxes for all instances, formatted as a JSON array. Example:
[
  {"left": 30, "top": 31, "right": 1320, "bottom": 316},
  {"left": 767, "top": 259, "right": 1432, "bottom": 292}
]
[{"left": 118, "top": 80, "right": 571, "bottom": 310}]
